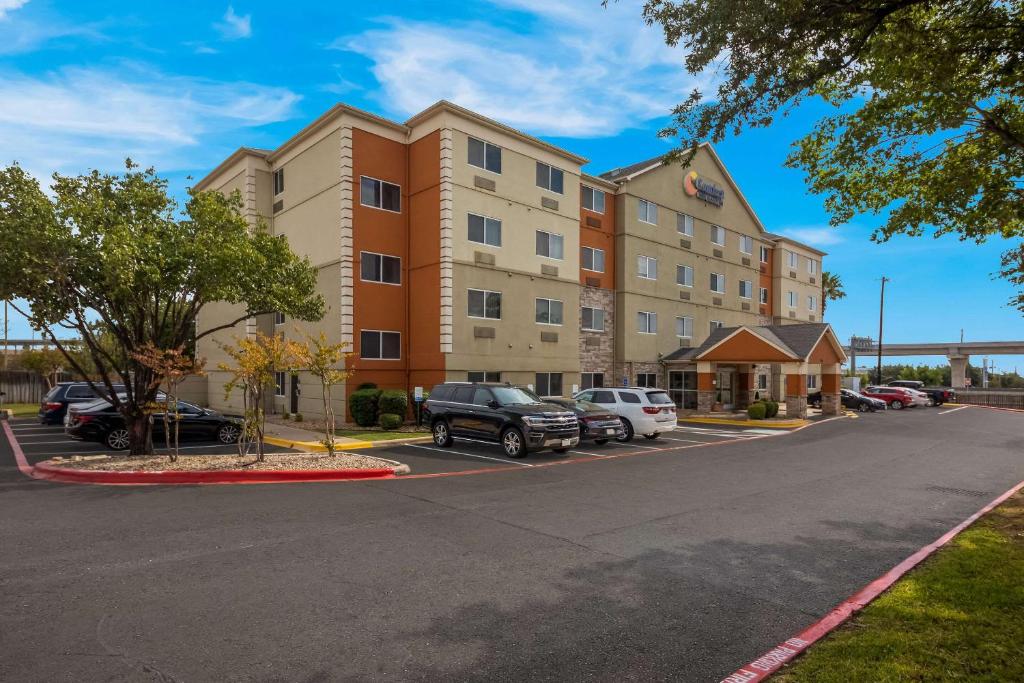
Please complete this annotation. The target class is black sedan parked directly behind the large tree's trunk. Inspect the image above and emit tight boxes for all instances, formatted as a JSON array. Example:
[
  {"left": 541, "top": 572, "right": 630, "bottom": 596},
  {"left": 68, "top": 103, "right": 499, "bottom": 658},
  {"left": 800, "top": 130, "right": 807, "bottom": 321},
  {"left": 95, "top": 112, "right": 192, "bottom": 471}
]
[{"left": 65, "top": 398, "right": 244, "bottom": 451}]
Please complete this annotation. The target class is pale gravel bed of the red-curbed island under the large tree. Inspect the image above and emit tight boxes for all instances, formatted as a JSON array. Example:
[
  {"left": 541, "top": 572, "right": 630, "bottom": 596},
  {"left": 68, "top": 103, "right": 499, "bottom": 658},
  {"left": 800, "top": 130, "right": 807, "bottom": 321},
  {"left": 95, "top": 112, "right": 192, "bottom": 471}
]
[{"left": 49, "top": 453, "right": 394, "bottom": 472}]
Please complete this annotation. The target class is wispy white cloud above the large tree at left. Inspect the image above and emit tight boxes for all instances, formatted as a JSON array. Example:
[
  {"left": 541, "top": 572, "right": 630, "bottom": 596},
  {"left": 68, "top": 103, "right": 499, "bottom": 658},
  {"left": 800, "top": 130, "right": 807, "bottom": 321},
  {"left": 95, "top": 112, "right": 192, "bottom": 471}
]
[{"left": 0, "top": 66, "right": 299, "bottom": 177}]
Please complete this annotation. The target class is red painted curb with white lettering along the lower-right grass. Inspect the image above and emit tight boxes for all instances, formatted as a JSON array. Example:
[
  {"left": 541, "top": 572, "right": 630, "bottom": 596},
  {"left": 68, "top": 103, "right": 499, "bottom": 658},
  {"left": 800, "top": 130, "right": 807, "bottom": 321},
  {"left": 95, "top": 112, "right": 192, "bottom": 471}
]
[{"left": 722, "top": 481, "right": 1024, "bottom": 683}]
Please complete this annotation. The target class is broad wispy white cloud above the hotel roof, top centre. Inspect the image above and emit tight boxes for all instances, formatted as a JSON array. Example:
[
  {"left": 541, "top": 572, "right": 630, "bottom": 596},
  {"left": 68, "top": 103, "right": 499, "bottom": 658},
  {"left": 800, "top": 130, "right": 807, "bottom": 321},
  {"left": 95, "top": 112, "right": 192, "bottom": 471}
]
[{"left": 330, "top": 0, "right": 708, "bottom": 137}]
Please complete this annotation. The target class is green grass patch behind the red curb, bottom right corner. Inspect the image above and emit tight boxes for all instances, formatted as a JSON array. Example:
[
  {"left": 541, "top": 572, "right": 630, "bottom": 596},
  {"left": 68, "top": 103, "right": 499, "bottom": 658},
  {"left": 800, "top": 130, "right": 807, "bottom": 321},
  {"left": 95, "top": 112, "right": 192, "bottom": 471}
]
[{"left": 772, "top": 494, "right": 1024, "bottom": 683}]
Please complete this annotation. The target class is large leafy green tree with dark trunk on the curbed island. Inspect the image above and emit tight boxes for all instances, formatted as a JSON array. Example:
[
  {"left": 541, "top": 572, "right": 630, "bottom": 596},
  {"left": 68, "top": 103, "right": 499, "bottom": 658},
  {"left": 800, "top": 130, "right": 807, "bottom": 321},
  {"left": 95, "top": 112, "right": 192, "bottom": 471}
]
[{"left": 0, "top": 161, "right": 324, "bottom": 455}]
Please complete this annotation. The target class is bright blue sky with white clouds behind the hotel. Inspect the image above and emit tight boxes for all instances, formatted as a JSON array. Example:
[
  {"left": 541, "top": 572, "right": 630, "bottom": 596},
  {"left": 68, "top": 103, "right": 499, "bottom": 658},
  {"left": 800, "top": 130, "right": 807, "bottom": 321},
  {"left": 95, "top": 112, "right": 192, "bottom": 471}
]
[{"left": 0, "top": 0, "right": 1024, "bottom": 372}]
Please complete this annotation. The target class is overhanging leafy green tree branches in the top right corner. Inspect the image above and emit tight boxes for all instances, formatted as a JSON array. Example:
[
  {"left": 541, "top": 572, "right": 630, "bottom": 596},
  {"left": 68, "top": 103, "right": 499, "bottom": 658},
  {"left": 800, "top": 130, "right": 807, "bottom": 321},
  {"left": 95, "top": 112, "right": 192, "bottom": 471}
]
[{"left": 643, "top": 0, "right": 1024, "bottom": 305}]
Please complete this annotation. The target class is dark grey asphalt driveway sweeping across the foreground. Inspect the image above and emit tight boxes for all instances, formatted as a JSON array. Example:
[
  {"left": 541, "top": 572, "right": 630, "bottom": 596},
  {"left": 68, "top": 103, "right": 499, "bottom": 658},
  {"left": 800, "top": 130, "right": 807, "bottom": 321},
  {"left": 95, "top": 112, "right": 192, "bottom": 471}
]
[{"left": 0, "top": 409, "right": 1024, "bottom": 681}]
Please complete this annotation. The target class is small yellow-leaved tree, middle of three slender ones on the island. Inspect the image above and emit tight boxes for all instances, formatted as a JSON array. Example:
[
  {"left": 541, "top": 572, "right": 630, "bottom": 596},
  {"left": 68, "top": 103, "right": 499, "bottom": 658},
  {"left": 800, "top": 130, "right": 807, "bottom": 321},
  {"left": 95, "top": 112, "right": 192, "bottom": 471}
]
[{"left": 217, "top": 332, "right": 302, "bottom": 463}]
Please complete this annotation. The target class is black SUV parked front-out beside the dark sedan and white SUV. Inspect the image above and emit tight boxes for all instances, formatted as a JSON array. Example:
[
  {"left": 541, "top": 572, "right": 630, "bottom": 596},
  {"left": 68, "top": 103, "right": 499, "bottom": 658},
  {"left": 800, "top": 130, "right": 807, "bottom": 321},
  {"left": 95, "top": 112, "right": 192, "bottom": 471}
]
[{"left": 424, "top": 382, "right": 580, "bottom": 458}]
